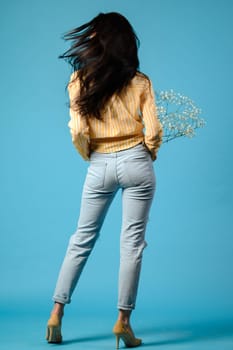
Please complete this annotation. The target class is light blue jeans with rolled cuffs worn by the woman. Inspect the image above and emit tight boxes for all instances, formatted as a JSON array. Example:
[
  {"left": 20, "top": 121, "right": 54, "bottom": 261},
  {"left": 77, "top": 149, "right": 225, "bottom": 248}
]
[{"left": 53, "top": 144, "right": 155, "bottom": 310}]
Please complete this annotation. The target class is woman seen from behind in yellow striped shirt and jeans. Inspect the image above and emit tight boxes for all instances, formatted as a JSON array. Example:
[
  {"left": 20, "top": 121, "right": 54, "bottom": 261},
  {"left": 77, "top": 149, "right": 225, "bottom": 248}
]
[{"left": 47, "top": 13, "right": 162, "bottom": 348}]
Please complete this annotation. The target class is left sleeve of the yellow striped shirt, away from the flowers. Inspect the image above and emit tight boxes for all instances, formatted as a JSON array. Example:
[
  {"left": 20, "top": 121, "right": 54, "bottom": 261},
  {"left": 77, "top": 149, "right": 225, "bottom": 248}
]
[{"left": 68, "top": 73, "right": 90, "bottom": 160}]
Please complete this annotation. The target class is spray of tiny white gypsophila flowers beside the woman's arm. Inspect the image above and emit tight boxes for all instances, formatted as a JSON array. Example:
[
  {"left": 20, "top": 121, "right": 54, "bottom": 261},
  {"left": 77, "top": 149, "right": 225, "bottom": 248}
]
[{"left": 155, "top": 89, "right": 206, "bottom": 143}]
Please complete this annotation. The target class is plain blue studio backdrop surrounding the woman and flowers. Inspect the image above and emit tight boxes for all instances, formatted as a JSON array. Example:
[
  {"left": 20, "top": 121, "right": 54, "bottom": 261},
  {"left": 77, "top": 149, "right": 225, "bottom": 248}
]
[{"left": 0, "top": 0, "right": 233, "bottom": 350}]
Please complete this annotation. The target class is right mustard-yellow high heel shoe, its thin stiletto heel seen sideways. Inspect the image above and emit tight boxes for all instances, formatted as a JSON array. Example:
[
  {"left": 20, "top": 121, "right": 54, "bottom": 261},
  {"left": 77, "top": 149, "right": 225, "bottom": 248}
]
[{"left": 113, "top": 320, "right": 142, "bottom": 349}]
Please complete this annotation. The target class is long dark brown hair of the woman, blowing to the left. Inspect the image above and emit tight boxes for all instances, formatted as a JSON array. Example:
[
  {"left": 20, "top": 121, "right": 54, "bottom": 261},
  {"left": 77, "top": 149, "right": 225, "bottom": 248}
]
[{"left": 59, "top": 12, "right": 139, "bottom": 119}]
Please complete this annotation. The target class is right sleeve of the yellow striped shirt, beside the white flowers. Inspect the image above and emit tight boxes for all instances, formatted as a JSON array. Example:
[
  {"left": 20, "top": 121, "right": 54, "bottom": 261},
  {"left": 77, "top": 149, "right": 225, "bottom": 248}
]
[{"left": 141, "top": 81, "right": 163, "bottom": 160}]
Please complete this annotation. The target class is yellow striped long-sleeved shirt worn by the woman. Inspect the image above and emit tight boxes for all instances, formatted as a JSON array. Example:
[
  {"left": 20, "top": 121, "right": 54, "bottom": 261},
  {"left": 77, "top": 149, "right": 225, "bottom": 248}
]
[{"left": 68, "top": 72, "right": 162, "bottom": 159}]
